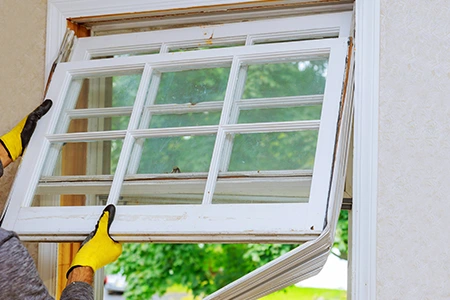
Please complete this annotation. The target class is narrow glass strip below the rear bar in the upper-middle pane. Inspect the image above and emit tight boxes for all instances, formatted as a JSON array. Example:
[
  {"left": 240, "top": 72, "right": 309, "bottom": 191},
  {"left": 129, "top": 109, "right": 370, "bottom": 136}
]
[{"left": 150, "top": 111, "right": 220, "bottom": 128}]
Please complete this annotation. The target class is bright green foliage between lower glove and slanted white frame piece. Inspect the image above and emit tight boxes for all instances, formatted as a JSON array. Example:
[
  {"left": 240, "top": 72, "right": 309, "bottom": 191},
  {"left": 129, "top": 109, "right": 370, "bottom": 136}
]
[{"left": 108, "top": 243, "right": 295, "bottom": 299}]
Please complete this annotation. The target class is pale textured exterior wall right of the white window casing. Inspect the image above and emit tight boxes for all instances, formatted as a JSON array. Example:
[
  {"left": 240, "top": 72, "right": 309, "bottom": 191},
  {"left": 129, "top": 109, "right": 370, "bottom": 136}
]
[{"left": 377, "top": 0, "right": 450, "bottom": 300}]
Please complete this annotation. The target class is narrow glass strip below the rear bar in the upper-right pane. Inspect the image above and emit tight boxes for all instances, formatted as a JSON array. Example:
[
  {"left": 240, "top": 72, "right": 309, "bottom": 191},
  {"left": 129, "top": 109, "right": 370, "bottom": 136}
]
[{"left": 238, "top": 105, "right": 322, "bottom": 123}]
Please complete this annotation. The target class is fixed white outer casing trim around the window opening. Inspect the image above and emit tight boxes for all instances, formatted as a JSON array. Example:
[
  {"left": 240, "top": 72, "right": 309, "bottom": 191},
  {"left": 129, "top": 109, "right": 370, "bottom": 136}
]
[{"left": 34, "top": 0, "right": 380, "bottom": 299}]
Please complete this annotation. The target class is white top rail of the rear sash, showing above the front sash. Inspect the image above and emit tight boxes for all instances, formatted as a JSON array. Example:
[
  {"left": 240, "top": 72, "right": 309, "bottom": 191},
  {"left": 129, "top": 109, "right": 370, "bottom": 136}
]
[{"left": 71, "top": 12, "right": 351, "bottom": 61}]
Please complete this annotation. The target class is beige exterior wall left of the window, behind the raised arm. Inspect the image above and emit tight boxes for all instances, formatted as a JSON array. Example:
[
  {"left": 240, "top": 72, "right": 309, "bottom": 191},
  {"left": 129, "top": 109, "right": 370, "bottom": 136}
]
[{"left": 0, "top": 0, "right": 47, "bottom": 212}]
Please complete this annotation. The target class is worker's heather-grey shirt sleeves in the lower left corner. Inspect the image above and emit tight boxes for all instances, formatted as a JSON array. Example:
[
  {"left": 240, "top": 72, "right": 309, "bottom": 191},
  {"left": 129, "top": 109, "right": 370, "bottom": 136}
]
[{"left": 0, "top": 228, "right": 94, "bottom": 300}]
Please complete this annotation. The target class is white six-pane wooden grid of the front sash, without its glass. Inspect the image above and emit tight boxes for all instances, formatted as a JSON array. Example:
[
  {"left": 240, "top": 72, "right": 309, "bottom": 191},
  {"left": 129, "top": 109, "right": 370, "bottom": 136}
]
[{"left": 3, "top": 18, "right": 348, "bottom": 242}]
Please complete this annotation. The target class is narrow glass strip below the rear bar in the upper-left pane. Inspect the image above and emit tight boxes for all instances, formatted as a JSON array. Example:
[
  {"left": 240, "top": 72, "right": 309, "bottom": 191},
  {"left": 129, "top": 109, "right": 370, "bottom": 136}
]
[{"left": 67, "top": 115, "right": 130, "bottom": 133}]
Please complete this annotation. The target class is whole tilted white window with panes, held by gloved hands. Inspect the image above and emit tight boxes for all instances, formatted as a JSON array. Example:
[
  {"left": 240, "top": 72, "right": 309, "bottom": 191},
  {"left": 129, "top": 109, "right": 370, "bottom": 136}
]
[{"left": 4, "top": 8, "right": 351, "bottom": 299}]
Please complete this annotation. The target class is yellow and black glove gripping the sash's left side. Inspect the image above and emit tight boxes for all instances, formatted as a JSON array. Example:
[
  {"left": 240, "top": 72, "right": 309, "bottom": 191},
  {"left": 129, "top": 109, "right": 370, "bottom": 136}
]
[{"left": 0, "top": 99, "right": 53, "bottom": 161}]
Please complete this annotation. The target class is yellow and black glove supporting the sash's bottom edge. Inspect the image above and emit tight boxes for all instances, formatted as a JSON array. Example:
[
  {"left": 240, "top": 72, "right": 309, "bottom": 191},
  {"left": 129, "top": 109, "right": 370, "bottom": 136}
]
[{"left": 67, "top": 204, "right": 122, "bottom": 276}]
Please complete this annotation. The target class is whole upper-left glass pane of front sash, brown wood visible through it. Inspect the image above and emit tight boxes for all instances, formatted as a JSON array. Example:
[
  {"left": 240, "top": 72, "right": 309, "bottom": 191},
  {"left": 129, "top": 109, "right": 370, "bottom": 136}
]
[{"left": 56, "top": 73, "right": 141, "bottom": 133}]
